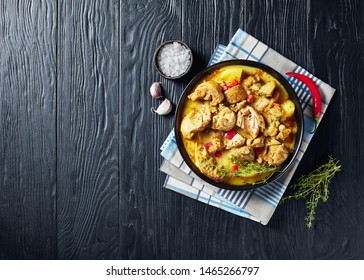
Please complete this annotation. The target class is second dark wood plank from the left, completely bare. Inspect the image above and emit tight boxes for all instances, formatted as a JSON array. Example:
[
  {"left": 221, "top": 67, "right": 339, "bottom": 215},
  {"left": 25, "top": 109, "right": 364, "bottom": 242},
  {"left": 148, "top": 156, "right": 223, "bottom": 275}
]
[{"left": 57, "top": 1, "right": 120, "bottom": 259}]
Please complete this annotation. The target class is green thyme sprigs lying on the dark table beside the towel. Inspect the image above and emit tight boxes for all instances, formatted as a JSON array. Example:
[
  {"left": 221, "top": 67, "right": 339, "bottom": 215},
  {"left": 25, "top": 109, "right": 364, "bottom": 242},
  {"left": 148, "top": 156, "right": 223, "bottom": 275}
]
[{"left": 280, "top": 156, "right": 341, "bottom": 228}]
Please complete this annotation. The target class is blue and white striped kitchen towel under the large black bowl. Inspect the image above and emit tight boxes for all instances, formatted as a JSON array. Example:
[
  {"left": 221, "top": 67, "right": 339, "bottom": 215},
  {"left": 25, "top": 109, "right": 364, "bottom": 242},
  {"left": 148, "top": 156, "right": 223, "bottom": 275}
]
[{"left": 160, "top": 29, "right": 335, "bottom": 225}]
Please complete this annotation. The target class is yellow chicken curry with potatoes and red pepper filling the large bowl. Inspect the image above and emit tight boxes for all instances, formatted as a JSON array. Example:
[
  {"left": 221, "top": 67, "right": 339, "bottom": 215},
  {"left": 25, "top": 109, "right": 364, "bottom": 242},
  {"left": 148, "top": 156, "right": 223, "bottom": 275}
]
[{"left": 180, "top": 65, "right": 297, "bottom": 185}]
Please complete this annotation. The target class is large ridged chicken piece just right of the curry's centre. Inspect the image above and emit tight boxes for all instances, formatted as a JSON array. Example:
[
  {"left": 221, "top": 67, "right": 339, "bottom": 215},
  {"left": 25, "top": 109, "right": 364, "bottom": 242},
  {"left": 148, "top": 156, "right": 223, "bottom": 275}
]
[{"left": 236, "top": 106, "right": 265, "bottom": 139}]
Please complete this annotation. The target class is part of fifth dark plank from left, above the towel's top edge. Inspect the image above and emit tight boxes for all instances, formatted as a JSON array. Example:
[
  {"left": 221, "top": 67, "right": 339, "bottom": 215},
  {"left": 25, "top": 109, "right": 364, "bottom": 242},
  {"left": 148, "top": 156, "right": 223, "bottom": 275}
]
[{"left": 245, "top": 0, "right": 312, "bottom": 69}]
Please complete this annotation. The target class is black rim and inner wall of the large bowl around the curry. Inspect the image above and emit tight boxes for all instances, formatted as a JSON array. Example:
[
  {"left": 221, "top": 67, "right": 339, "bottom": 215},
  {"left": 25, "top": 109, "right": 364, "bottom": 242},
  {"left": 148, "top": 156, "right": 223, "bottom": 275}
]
[{"left": 175, "top": 60, "right": 303, "bottom": 190}]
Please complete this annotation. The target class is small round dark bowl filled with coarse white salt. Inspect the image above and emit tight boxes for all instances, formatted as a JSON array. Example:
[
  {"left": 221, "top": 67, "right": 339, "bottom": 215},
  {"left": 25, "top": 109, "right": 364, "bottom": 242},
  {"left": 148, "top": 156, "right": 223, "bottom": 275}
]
[{"left": 154, "top": 40, "right": 193, "bottom": 80}]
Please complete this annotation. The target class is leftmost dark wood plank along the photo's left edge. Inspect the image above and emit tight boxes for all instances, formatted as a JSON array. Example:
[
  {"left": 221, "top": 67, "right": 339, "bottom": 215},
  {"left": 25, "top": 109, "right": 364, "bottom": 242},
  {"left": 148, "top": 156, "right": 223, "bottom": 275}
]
[{"left": 0, "top": 1, "right": 57, "bottom": 259}]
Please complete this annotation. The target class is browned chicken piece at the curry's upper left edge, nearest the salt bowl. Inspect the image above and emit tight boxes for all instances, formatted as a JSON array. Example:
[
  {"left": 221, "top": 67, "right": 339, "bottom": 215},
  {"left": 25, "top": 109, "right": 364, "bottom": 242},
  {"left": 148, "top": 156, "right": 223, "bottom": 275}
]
[{"left": 188, "top": 81, "right": 224, "bottom": 106}]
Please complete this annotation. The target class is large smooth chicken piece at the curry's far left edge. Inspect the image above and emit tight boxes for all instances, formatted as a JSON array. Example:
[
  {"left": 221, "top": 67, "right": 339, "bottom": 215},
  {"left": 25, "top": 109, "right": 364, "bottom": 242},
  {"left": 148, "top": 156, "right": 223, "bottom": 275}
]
[{"left": 181, "top": 106, "right": 211, "bottom": 139}]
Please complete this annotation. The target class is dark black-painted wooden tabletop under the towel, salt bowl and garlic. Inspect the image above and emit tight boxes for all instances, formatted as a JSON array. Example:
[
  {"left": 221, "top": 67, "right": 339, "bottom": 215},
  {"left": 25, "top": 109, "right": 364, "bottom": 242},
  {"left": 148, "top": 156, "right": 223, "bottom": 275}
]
[{"left": 0, "top": 0, "right": 364, "bottom": 259}]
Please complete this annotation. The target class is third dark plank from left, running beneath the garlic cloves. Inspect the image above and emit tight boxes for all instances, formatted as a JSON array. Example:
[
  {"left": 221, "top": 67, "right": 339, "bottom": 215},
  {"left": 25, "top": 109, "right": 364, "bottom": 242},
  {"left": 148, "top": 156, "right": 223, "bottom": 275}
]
[{"left": 119, "top": 0, "right": 183, "bottom": 259}]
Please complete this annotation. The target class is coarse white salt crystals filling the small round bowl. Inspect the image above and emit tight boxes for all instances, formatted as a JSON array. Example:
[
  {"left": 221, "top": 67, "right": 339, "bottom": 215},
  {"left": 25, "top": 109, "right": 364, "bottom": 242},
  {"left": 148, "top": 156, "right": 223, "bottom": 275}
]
[{"left": 157, "top": 42, "right": 191, "bottom": 78}]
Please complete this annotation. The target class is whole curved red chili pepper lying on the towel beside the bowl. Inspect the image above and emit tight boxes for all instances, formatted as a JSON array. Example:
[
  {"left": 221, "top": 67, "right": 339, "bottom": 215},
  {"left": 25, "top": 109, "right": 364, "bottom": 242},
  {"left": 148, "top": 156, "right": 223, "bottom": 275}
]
[{"left": 286, "top": 72, "right": 322, "bottom": 133}]
